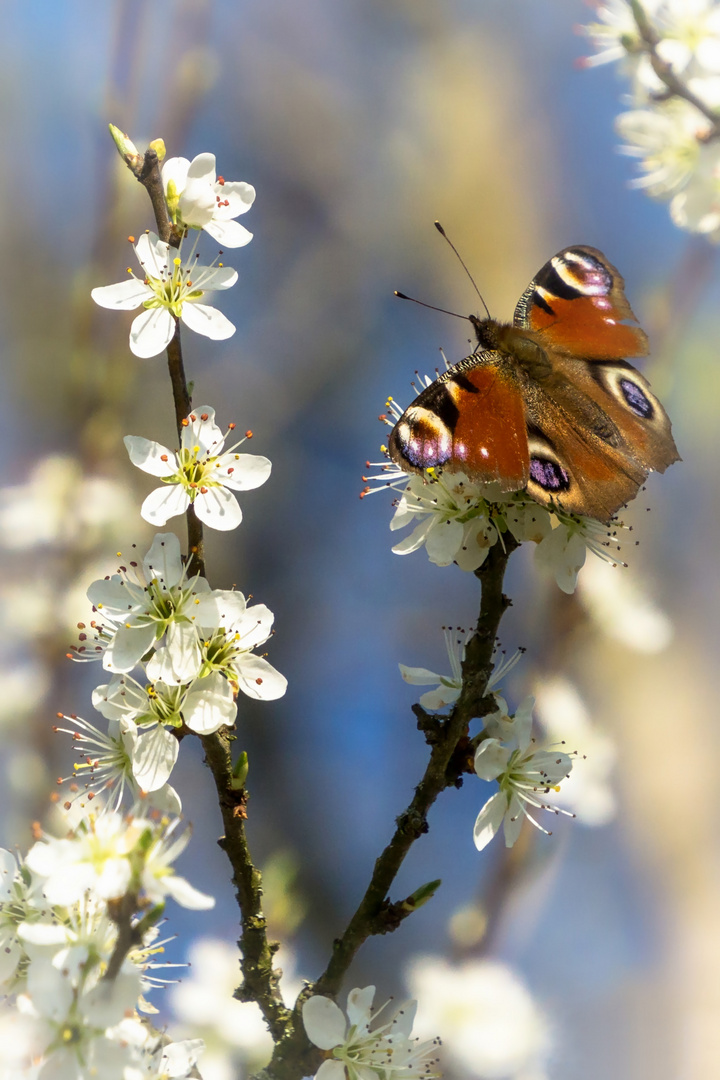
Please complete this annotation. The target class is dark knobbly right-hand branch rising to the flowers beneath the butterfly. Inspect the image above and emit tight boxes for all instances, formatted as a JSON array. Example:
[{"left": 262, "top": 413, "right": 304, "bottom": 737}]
[{"left": 260, "top": 534, "right": 517, "bottom": 1080}]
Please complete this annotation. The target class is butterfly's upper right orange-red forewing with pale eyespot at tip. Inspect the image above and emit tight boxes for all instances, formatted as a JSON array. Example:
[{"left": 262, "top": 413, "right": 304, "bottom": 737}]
[{"left": 514, "top": 244, "right": 648, "bottom": 360}]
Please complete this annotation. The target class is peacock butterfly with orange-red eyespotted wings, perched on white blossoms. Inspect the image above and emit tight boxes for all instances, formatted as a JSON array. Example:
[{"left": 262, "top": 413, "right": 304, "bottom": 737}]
[{"left": 389, "top": 245, "right": 680, "bottom": 522}]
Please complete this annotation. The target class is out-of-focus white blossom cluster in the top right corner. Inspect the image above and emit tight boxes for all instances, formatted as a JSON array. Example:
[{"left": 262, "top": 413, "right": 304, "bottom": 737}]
[{"left": 580, "top": 0, "right": 720, "bottom": 236}]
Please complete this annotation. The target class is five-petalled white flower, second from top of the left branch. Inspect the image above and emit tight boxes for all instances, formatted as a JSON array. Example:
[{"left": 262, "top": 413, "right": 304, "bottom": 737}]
[{"left": 91, "top": 232, "right": 237, "bottom": 359}]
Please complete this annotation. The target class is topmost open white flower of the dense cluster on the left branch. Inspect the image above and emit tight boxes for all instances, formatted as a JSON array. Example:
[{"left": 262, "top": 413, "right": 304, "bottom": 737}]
[{"left": 87, "top": 532, "right": 214, "bottom": 683}]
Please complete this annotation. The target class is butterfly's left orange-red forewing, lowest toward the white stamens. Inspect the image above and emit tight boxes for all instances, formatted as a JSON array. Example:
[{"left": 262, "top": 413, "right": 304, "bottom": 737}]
[{"left": 389, "top": 350, "right": 530, "bottom": 491}]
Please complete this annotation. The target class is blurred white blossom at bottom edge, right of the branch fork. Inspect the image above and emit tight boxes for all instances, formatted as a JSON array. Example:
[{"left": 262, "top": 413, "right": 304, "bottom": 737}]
[{"left": 407, "top": 956, "right": 551, "bottom": 1080}]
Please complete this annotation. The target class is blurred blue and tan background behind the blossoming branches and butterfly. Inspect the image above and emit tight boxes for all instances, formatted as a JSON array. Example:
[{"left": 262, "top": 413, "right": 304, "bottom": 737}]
[{"left": 0, "top": 0, "right": 720, "bottom": 1080}]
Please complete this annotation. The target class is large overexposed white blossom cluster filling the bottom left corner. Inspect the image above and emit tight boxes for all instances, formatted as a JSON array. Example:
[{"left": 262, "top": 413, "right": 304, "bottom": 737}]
[{"left": 0, "top": 808, "right": 215, "bottom": 1080}]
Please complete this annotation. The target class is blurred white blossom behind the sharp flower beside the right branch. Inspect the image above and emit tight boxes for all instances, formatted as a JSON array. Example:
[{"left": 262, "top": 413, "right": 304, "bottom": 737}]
[{"left": 535, "top": 675, "right": 617, "bottom": 825}]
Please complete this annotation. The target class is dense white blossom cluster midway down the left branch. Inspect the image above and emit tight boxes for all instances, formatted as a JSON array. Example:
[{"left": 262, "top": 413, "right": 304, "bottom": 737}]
[{"left": 60, "top": 532, "right": 287, "bottom": 810}]
